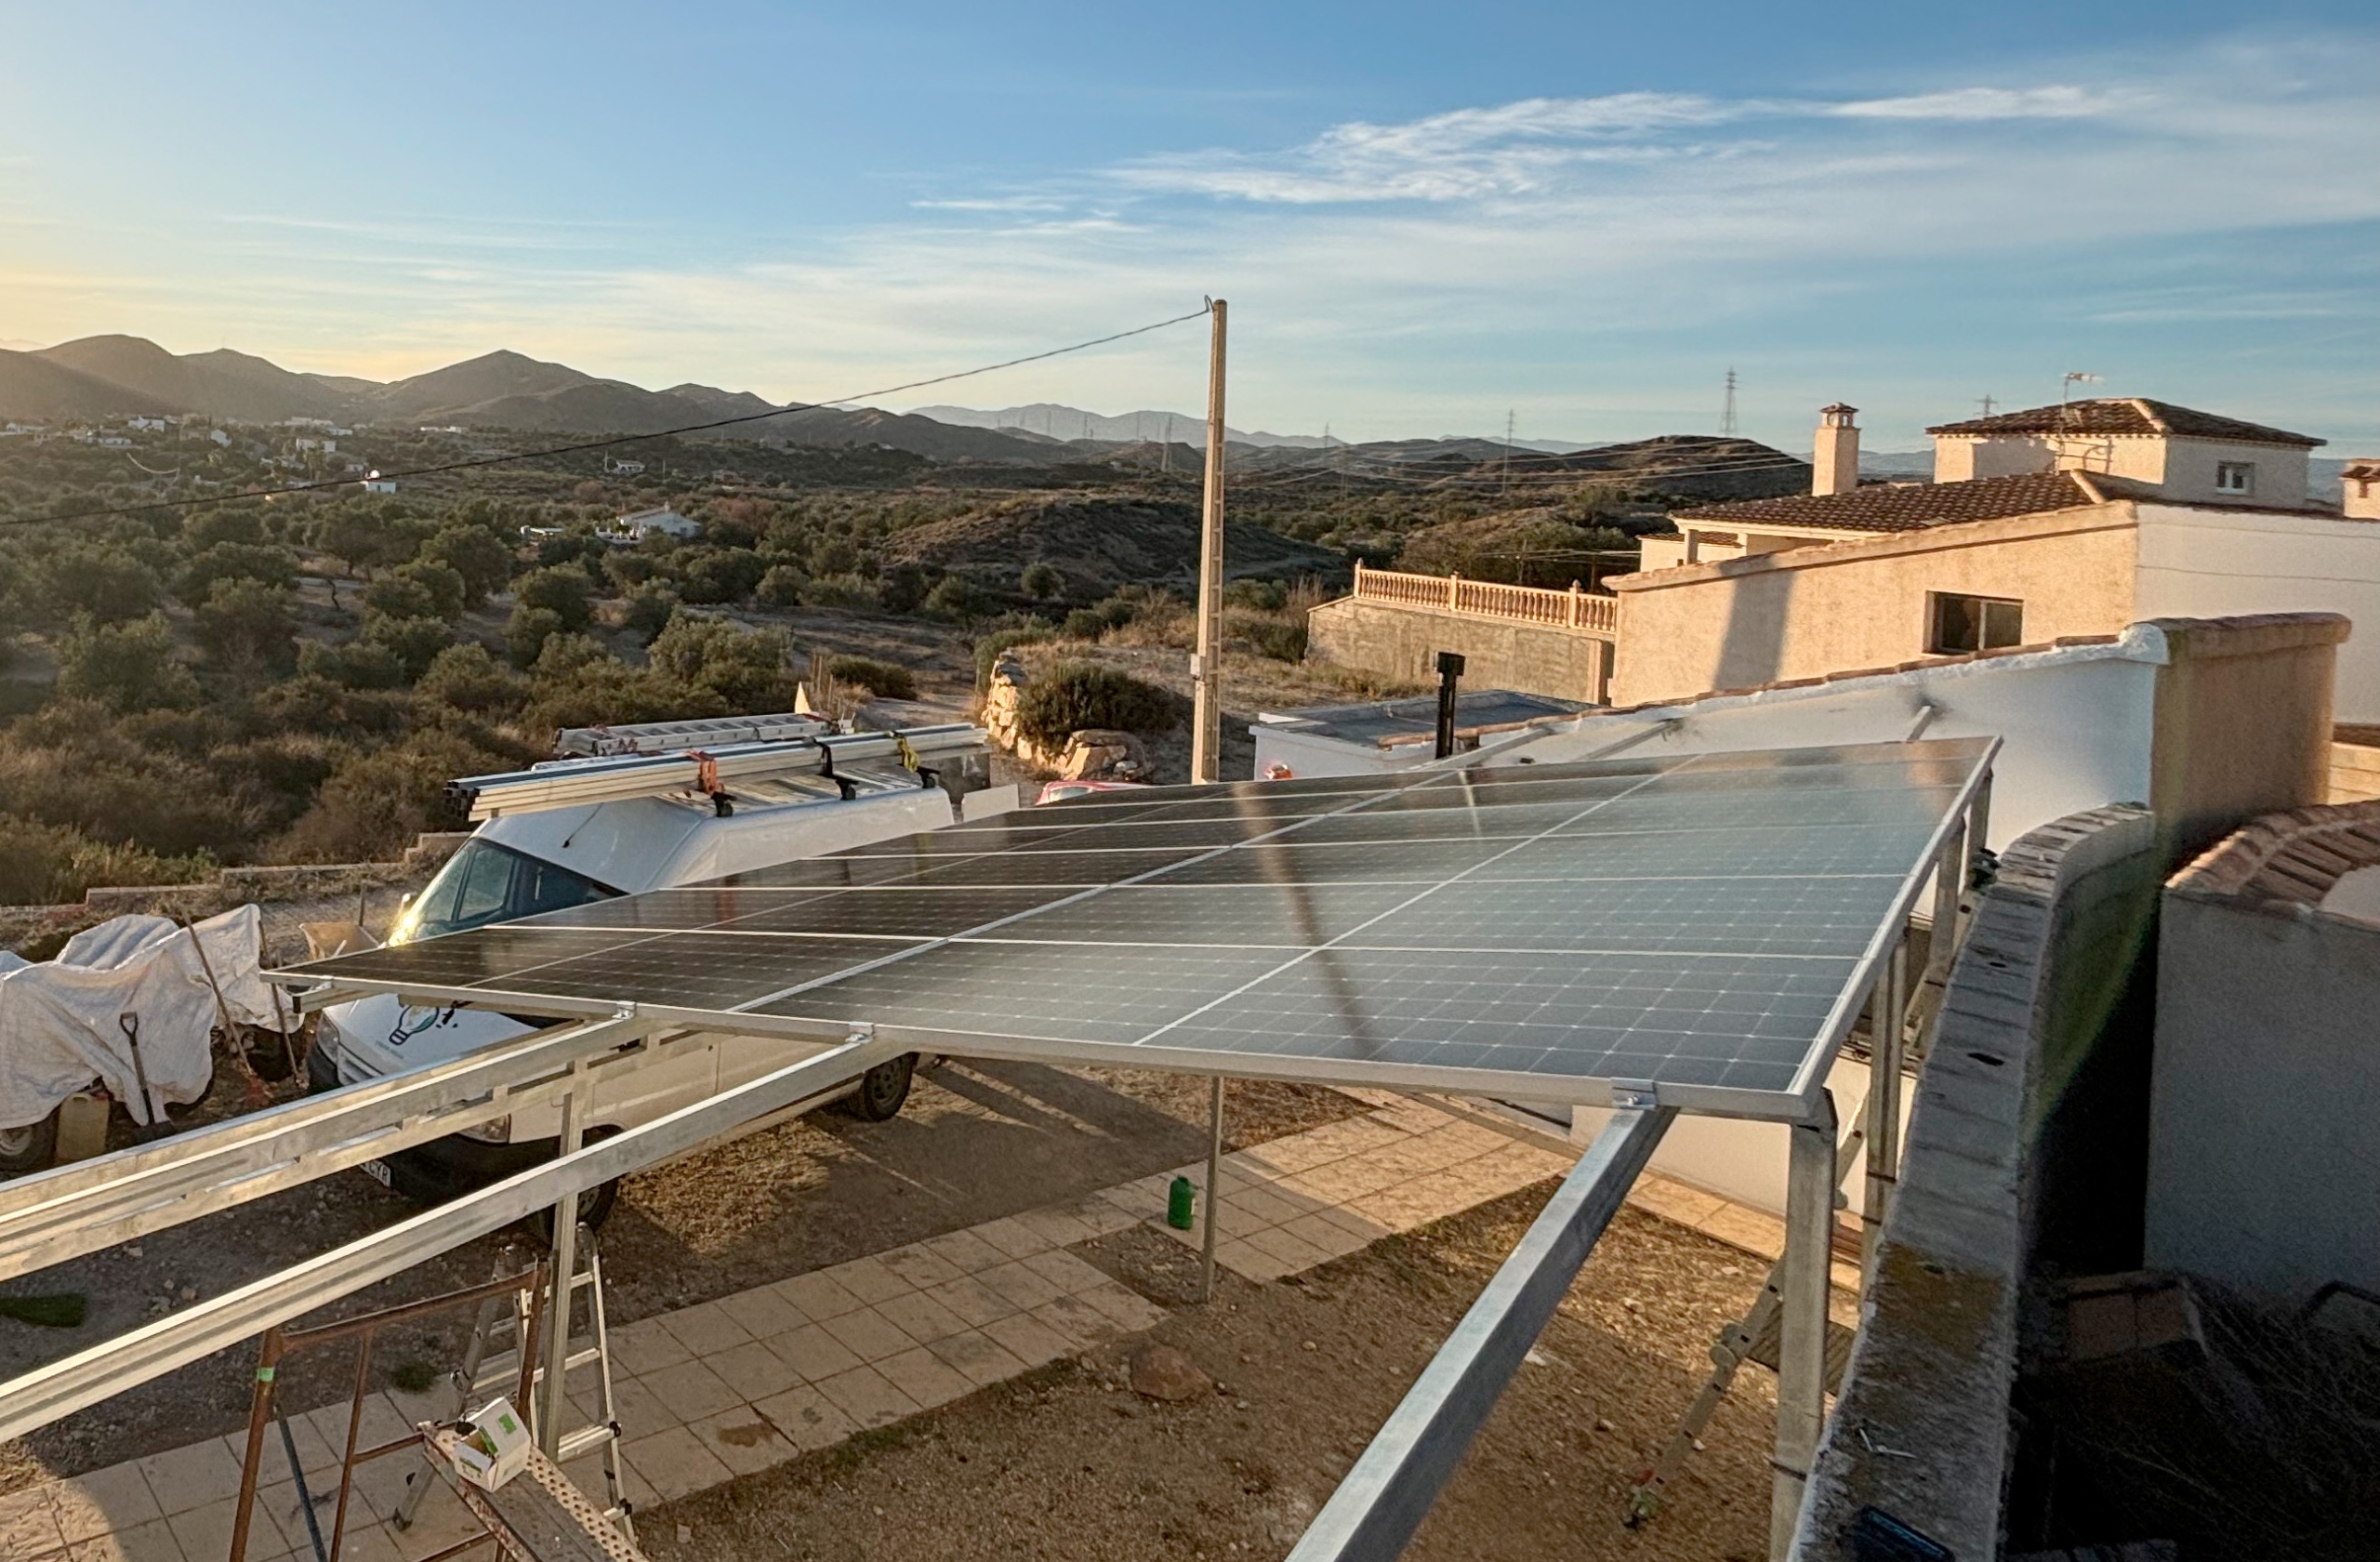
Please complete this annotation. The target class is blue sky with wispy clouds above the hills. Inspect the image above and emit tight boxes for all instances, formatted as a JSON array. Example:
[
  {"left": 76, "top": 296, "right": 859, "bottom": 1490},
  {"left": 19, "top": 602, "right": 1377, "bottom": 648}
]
[{"left": 0, "top": 0, "right": 2380, "bottom": 455}]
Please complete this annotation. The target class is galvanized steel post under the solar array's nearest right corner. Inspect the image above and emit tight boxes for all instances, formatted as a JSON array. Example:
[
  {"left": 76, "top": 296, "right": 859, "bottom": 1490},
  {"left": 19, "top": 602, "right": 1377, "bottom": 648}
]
[{"left": 1768, "top": 1091, "right": 1873, "bottom": 1562}]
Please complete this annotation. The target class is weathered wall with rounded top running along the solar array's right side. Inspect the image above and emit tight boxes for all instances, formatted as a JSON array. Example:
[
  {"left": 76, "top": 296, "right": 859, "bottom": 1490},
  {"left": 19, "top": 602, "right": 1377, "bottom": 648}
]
[{"left": 1792, "top": 807, "right": 2163, "bottom": 1562}]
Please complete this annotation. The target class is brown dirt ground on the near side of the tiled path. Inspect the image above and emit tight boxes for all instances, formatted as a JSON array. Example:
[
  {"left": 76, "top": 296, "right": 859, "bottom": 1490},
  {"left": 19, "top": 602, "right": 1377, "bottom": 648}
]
[{"left": 638, "top": 1184, "right": 1776, "bottom": 1562}]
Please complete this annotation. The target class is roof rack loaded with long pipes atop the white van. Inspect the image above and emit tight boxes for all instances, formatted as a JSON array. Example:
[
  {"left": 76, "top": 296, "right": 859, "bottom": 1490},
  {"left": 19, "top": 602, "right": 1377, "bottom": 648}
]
[{"left": 447, "top": 717, "right": 990, "bottom": 822}]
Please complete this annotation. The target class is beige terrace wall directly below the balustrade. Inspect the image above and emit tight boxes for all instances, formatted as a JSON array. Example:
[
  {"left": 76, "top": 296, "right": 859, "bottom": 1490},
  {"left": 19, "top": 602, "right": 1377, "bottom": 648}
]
[{"left": 1306, "top": 598, "right": 1611, "bottom": 705}]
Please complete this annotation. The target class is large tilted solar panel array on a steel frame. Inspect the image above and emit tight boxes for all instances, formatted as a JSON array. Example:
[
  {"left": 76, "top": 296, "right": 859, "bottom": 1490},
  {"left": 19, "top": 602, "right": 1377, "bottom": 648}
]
[{"left": 295, "top": 740, "right": 1990, "bottom": 1112}]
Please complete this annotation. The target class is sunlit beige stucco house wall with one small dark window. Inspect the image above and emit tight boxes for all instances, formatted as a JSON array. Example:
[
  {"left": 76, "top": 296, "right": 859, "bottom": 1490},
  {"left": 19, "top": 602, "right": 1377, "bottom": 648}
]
[{"left": 1609, "top": 502, "right": 2139, "bottom": 705}]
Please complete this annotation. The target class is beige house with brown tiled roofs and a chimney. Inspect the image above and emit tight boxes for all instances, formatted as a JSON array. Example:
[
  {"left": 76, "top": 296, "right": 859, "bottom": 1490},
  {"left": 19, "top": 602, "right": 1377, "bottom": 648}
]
[{"left": 1606, "top": 398, "right": 2380, "bottom": 724}]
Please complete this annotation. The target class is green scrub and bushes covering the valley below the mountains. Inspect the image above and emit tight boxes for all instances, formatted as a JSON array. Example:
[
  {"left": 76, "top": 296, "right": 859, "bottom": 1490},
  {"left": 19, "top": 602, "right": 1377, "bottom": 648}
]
[{"left": 0, "top": 426, "right": 1656, "bottom": 903}]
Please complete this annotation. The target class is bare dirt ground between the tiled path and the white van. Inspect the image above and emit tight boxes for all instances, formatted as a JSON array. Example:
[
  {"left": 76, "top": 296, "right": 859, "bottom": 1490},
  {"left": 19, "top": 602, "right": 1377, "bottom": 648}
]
[{"left": 0, "top": 1062, "right": 1364, "bottom": 1490}]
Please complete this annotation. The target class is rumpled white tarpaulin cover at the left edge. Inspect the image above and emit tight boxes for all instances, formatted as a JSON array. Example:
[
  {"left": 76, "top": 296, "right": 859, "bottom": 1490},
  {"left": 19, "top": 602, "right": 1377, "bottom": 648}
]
[{"left": 0, "top": 905, "right": 276, "bottom": 1129}]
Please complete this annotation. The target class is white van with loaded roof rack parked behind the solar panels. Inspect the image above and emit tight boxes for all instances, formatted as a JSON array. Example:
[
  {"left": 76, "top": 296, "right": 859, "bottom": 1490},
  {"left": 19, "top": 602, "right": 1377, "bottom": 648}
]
[{"left": 307, "top": 724, "right": 990, "bottom": 1226}]
